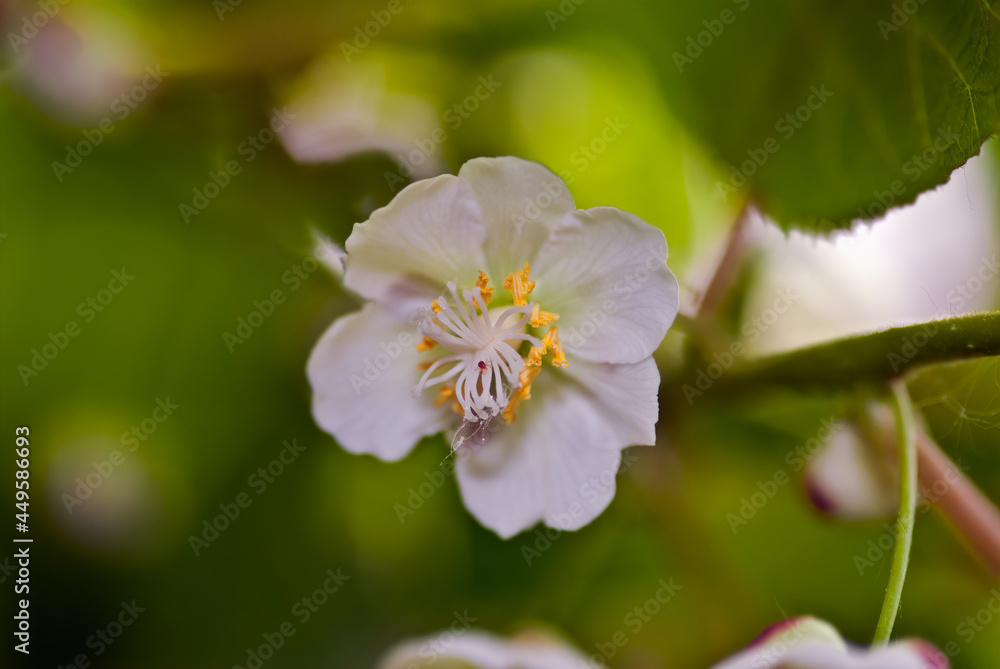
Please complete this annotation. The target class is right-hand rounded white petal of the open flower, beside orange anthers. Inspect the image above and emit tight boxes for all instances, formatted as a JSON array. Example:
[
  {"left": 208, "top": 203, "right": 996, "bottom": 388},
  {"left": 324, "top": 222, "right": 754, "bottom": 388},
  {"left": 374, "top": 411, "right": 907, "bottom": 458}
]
[{"left": 531, "top": 207, "right": 679, "bottom": 362}]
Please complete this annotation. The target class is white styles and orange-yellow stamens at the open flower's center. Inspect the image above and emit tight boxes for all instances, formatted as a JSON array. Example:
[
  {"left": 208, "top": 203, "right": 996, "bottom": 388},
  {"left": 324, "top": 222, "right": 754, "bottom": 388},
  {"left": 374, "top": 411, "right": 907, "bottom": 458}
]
[{"left": 413, "top": 263, "right": 567, "bottom": 423}]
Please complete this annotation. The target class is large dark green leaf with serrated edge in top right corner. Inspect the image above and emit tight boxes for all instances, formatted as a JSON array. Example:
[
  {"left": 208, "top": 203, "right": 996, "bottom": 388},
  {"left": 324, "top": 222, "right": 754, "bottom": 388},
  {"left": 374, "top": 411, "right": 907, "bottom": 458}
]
[{"left": 634, "top": 0, "right": 1000, "bottom": 232}]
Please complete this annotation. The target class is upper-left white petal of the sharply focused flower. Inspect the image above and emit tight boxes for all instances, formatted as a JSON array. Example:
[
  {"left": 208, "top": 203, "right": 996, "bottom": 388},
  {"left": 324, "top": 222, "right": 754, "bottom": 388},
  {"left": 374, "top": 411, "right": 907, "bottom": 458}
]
[{"left": 344, "top": 174, "right": 486, "bottom": 301}]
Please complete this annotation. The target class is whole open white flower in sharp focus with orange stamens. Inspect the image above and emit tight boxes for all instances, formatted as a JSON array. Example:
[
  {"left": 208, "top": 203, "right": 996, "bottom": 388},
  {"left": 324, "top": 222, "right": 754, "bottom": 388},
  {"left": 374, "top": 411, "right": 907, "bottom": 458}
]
[{"left": 308, "top": 157, "right": 678, "bottom": 538}]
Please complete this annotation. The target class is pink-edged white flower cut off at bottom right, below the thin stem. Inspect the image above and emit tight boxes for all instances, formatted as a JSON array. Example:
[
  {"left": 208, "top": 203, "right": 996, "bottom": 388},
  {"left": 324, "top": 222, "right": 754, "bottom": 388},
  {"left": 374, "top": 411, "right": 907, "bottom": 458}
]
[{"left": 712, "top": 616, "right": 949, "bottom": 669}]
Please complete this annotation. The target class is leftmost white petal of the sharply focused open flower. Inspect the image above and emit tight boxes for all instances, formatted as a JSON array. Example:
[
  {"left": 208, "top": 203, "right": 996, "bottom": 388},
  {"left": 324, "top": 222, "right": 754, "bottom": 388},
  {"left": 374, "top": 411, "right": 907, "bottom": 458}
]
[{"left": 306, "top": 304, "right": 452, "bottom": 460}]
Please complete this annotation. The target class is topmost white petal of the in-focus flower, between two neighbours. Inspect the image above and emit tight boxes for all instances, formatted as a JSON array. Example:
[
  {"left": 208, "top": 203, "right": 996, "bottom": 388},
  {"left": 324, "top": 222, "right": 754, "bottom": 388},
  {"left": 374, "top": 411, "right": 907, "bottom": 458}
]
[{"left": 458, "top": 156, "right": 575, "bottom": 282}]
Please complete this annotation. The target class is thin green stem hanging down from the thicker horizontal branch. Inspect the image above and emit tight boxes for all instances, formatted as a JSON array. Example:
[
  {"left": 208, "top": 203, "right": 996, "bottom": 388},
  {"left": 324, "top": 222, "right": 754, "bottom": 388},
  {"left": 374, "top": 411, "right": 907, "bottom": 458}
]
[{"left": 872, "top": 379, "right": 917, "bottom": 646}]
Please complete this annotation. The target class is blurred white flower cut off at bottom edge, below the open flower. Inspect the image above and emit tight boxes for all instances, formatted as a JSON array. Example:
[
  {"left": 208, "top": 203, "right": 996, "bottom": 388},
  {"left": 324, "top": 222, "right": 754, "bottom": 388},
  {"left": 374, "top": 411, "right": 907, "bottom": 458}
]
[{"left": 379, "top": 630, "right": 587, "bottom": 669}]
